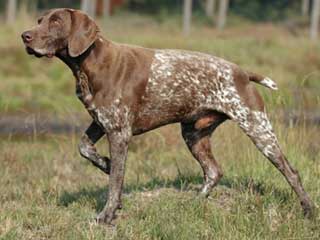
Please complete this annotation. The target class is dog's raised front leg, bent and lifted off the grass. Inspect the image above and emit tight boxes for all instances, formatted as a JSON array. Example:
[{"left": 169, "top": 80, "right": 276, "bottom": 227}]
[{"left": 79, "top": 121, "right": 110, "bottom": 174}]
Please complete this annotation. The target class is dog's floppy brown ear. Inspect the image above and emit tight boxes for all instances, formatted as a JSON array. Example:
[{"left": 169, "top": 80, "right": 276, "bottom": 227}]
[{"left": 68, "top": 10, "right": 99, "bottom": 57}]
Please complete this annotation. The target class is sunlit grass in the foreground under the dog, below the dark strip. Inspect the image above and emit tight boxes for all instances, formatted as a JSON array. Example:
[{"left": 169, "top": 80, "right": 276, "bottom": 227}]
[{"left": 0, "top": 123, "right": 320, "bottom": 239}]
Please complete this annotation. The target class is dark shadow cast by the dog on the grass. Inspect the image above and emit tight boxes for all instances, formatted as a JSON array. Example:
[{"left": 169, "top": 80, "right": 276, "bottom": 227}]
[{"left": 58, "top": 176, "right": 292, "bottom": 211}]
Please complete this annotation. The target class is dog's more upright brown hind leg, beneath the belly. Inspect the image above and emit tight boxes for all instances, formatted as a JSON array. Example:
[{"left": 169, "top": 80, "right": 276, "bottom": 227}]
[{"left": 181, "top": 114, "right": 226, "bottom": 197}]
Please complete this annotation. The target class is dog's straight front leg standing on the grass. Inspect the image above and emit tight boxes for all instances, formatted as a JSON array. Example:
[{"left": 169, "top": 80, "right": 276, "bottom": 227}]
[{"left": 97, "top": 128, "right": 132, "bottom": 224}]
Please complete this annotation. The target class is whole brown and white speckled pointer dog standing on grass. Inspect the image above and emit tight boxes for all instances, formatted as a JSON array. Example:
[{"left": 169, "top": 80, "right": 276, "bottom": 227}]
[{"left": 22, "top": 9, "right": 313, "bottom": 223}]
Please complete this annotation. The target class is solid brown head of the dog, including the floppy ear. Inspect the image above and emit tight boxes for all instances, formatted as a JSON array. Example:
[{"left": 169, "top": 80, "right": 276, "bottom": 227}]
[{"left": 21, "top": 9, "right": 99, "bottom": 57}]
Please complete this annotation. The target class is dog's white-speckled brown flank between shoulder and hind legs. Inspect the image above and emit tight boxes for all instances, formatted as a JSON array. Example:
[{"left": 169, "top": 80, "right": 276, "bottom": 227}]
[{"left": 134, "top": 50, "right": 240, "bottom": 133}]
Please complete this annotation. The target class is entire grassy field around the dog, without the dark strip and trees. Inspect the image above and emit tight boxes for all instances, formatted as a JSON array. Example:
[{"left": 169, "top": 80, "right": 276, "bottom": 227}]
[{"left": 0, "top": 11, "right": 320, "bottom": 240}]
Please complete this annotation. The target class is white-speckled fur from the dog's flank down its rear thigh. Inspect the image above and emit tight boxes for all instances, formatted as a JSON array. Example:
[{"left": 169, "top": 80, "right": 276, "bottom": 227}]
[{"left": 140, "top": 50, "right": 279, "bottom": 159}]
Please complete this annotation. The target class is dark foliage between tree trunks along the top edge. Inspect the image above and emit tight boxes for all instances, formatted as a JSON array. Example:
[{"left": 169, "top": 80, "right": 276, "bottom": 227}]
[{"left": 0, "top": 0, "right": 310, "bottom": 22}]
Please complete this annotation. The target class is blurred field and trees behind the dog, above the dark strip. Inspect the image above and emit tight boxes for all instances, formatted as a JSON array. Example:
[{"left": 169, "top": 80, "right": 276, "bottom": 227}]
[{"left": 0, "top": 0, "right": 320, "bottom": 132}]
